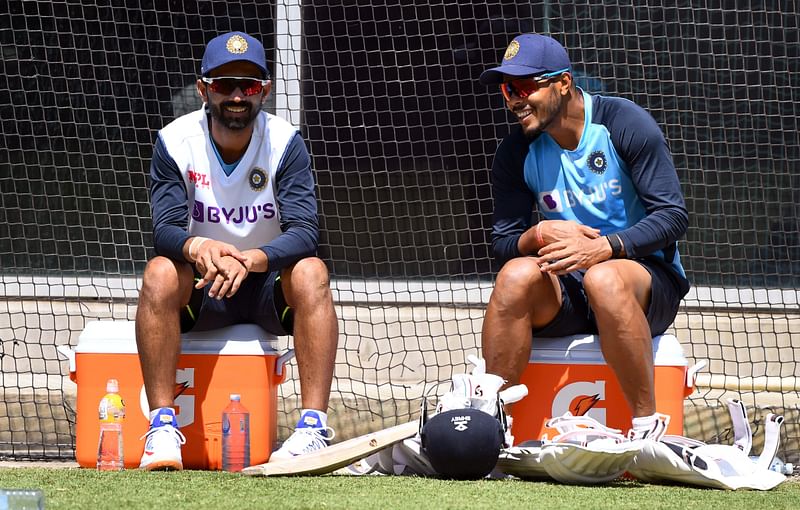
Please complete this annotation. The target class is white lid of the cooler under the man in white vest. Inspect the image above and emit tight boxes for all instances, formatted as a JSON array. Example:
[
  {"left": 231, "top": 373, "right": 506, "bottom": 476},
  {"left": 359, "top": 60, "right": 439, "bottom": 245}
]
[{"left": 75, "top": 321, "right": 276, "bottom": 356}]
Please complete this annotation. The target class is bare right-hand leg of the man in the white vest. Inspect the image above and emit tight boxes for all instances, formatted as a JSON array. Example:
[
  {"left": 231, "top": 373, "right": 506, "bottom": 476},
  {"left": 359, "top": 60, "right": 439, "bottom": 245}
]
[{"left": 281, "top": 257, "right": 339, "bottom": 412}]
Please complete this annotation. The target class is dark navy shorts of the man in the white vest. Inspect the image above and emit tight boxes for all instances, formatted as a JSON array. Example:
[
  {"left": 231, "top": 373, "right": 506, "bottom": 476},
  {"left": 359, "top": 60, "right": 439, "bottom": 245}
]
[{"left": 181, "top": 271, "right": 294, "bottom": 336}]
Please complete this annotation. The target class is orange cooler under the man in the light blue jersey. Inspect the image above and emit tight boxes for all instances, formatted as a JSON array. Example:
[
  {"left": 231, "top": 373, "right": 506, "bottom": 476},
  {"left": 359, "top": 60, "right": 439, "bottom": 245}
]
[{"left": 511, "top": 335, "right": 694, "bottom": 443}]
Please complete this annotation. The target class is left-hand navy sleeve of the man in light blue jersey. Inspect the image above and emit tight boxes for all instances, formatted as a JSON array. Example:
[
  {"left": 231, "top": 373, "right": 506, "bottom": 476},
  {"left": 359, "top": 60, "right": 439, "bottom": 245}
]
[{"left": 492, "top": 128, "right": 535, "bottom": 266}]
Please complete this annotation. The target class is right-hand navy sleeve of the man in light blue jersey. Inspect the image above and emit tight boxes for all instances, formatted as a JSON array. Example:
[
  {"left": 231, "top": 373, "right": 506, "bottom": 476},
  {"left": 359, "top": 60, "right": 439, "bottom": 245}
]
[{"left": 593, "top": 96, "right": 689, "bottom": 262}]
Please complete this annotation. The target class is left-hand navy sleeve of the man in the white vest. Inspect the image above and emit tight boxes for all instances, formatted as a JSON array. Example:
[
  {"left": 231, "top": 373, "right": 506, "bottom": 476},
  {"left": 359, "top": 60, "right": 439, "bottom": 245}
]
[{"left": 150, "top": 136, "right": 189, "bottom": 262}]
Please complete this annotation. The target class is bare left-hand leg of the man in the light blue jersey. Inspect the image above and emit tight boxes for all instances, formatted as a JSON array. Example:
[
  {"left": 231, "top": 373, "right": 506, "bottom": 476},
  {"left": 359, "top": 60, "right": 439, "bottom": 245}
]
[{"left": 481, "top": 257, "right": 561, "bottom": 385}]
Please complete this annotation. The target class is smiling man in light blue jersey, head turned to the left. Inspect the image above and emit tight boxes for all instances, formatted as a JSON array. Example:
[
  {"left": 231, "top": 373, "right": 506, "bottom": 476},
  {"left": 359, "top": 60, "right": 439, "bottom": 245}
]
[{"left": 480, "top": 34, "right": 689, "bottom": 438}]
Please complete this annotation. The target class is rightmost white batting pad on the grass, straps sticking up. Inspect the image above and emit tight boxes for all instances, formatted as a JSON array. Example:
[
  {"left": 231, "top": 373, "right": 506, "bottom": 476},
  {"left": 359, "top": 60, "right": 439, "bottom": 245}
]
[{"left": 628, "top": 400, "right": 786, "bottom": 490}]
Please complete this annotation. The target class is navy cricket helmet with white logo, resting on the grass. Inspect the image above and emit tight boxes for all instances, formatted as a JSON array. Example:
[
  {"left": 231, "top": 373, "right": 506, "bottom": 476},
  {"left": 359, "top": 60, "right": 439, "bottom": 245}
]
[{"left": 420, "top": 409, "right": 504, "bottom": 480}]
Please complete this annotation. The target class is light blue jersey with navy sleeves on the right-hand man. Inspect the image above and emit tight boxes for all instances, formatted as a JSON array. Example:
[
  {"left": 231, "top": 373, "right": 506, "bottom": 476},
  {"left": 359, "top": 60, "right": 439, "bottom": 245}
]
[{"left": 492, "top": 91, "right": 689, "bottom": 278}]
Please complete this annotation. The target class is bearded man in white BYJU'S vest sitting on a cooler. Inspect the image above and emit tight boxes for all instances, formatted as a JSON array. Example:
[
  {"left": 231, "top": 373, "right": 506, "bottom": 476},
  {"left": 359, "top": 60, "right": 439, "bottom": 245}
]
[{"left": 136, "top": 32, "right": 339, "bottom": 470}]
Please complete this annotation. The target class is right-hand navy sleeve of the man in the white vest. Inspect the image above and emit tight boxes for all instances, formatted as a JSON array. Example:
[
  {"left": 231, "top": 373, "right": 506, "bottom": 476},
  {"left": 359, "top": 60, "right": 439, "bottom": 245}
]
[{"left": 261, "top": 133, "right": 319, "bottom": 271}]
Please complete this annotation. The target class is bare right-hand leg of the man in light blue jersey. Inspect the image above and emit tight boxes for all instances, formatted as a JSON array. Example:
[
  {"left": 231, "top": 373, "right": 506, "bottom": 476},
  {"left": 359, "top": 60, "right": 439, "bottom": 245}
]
[{"left": 583, "top": 260, "right": 656, "bottom": 417}]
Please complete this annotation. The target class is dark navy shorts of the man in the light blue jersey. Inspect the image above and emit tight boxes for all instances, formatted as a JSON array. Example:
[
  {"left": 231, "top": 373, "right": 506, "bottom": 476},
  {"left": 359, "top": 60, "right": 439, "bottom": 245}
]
[{"left": 533, "top": 257, "right": 689, "bottom": 338}]
